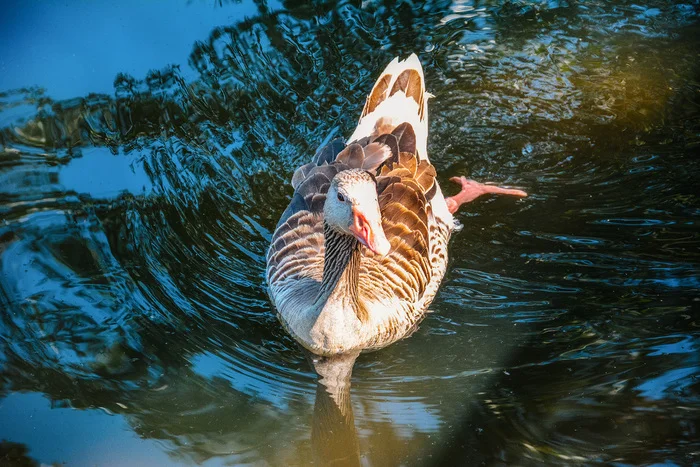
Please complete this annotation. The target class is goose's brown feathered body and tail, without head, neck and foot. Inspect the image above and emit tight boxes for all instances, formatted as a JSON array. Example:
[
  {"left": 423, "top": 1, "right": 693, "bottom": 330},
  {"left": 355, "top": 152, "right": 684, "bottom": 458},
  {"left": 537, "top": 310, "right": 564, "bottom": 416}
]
[{"left": 266, "top": 55, "right": 454, "bottom": 355}]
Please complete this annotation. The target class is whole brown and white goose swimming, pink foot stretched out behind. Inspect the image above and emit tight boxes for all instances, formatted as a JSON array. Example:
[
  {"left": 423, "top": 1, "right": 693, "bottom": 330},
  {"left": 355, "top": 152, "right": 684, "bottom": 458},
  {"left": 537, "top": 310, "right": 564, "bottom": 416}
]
[{"left": 266, "top": 54, "right": 527, "bottom": 356}]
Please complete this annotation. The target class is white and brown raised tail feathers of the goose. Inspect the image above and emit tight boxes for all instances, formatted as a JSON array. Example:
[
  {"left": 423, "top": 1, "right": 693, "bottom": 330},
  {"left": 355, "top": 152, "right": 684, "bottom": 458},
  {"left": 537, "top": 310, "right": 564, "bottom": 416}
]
[{"left": 348, "top": 54, "right": 433, "bottom": 160}]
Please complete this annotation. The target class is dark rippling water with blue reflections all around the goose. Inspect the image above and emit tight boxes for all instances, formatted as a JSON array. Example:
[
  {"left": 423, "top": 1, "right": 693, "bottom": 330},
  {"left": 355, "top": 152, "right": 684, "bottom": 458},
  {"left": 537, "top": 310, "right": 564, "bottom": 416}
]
[{"left": 0, "top": 0, "right": 700, "bottom": 465}]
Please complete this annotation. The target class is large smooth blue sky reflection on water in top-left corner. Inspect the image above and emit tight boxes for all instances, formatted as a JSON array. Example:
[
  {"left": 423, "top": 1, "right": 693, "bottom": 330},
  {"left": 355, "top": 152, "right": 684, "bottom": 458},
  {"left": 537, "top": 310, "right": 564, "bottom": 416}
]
[{"left": 0, "top": 0, "right": 279, "bottom": 99}]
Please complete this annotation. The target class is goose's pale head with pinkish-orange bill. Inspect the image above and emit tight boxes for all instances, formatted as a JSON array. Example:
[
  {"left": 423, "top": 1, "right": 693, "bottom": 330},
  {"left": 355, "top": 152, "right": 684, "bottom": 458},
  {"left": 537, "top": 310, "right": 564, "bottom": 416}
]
[{"left": 323, "top": 169, "right": 391, "bottom": 256}]
